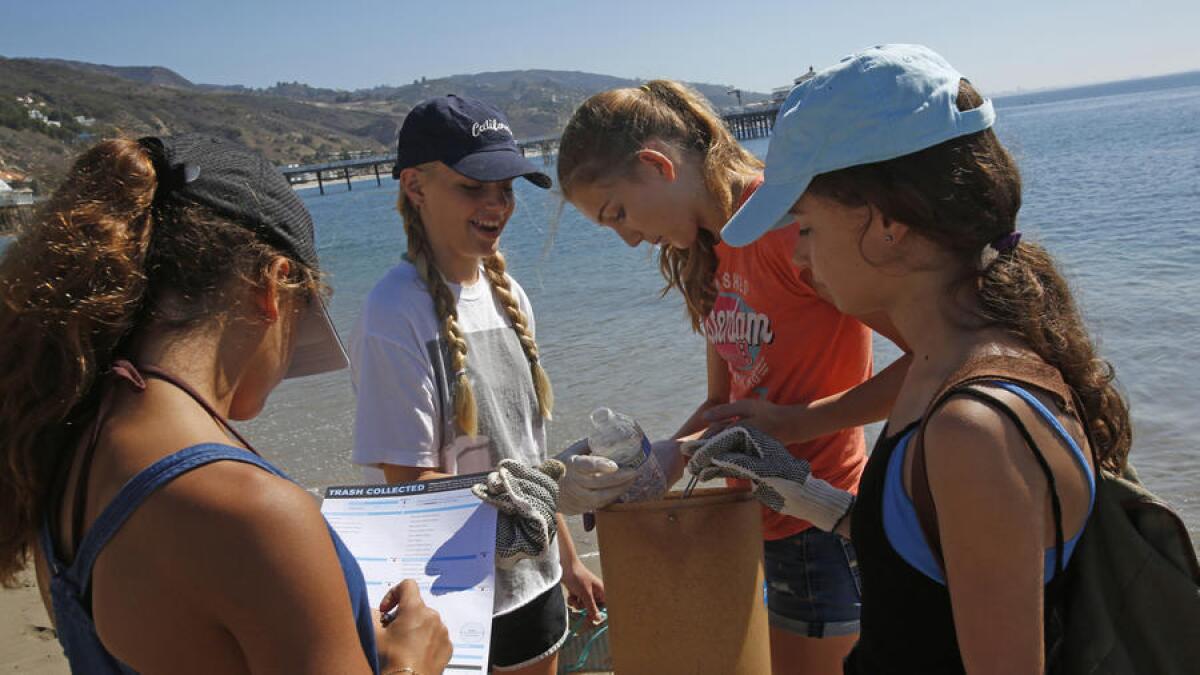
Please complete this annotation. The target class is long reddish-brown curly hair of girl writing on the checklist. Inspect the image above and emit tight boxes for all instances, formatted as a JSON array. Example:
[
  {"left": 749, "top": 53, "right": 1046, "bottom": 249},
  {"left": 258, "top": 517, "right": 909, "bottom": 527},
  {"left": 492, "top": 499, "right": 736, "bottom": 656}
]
[{"left": 0, "top": 139, "right": 322, "bottom": 586}]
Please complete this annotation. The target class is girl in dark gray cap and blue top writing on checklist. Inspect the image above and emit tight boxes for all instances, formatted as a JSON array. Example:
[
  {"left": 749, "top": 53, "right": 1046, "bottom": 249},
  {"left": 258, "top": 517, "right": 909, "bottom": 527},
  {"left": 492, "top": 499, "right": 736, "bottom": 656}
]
[{"left": 0, "top": 135, "right": 450, "bottom": 675}]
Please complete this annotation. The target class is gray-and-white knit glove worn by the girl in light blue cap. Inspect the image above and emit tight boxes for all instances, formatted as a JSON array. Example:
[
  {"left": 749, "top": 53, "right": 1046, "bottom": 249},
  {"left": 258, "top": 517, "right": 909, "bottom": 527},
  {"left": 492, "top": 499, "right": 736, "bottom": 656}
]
[{"left": 688, "top": 424, "right": 854, "bottom": 532}]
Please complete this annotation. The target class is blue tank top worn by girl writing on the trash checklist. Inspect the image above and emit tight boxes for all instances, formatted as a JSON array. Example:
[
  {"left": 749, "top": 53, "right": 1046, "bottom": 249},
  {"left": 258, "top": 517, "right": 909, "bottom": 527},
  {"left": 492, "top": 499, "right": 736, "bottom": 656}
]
[{"left": 38, "top": 443, "right": 379, "bottom": 675}]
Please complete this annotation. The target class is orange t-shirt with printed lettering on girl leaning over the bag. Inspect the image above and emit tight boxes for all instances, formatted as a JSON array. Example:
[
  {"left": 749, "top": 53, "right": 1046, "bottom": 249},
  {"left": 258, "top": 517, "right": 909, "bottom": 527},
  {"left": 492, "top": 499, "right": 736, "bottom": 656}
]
[{"left": 704, "top": 177, "right": 871, "bottom": 539}]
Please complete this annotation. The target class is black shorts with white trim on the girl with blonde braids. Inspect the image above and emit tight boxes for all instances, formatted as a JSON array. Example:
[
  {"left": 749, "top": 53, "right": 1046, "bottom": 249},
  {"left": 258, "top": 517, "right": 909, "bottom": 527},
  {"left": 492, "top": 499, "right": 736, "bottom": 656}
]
[{"left": 487, "top": 584, "right": 568, "bottom": 670}]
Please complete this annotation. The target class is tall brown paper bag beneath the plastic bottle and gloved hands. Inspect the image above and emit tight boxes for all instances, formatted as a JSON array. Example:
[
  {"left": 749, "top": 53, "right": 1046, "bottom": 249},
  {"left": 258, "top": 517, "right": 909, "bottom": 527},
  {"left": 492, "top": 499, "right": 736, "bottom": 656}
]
[{"left": 596, "top": 488, "right": 770, "bottom": 675}]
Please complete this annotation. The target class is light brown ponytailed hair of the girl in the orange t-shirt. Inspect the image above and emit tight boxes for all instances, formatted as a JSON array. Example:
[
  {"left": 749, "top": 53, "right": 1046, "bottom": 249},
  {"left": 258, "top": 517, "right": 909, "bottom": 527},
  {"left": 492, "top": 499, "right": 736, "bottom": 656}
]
[{"left": 558, "top": 79, "right": 762, "bottom": 333}]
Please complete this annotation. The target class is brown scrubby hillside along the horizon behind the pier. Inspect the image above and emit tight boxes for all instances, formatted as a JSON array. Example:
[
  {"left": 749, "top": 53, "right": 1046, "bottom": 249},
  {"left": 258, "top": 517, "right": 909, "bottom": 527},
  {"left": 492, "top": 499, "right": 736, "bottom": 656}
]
[{"left": 0, "top": 58, "right": 766, "bottom": 193}]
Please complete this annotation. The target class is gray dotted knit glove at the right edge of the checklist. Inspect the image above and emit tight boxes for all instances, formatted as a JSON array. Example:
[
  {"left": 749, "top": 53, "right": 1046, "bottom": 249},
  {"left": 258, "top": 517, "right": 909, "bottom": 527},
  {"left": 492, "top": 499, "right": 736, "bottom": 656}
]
[{"left": 470, "top": 459, "right": 565, "bottom": 568}]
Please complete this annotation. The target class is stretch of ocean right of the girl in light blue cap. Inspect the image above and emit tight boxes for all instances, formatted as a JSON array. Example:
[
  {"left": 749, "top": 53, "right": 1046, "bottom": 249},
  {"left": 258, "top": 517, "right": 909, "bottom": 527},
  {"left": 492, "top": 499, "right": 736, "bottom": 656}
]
[{"left": 997, "top": 85, "right": 1200, "bottom": 539}]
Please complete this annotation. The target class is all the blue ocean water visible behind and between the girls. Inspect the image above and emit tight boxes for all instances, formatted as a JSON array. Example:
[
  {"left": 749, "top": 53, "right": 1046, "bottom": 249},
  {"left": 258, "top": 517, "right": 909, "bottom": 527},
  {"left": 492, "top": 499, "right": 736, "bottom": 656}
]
[{"left": 246, "top": 78, "right": 1200, "bottom": 537}]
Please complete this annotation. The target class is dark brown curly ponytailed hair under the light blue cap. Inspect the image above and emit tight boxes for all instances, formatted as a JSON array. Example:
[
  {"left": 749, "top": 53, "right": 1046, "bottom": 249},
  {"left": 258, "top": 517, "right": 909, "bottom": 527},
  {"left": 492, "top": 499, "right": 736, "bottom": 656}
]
[{"left": 808, "top": 80, "right": 1133, "bottom": 472}]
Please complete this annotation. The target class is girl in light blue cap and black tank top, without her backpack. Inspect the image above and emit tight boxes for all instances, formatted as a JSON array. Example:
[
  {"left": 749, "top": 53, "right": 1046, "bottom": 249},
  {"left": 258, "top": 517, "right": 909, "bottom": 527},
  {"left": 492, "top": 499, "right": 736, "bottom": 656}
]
[{"left": 690, "top": 44, "right": 1130, "bottom": 674}]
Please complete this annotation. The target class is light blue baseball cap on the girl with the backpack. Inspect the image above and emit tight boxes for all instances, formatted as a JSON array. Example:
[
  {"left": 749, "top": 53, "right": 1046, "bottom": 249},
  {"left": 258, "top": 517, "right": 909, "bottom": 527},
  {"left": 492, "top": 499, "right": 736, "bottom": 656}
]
[{"left": 721, "top": 44, "right": 996, "bottom": 246}]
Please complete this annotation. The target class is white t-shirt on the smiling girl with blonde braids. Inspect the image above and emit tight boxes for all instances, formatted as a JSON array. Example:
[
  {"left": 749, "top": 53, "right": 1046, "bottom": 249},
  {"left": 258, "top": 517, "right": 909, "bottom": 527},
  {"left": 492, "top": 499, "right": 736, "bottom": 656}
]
[{"left": 350, "top": 261, "right": 562, "bottom": 615}]
